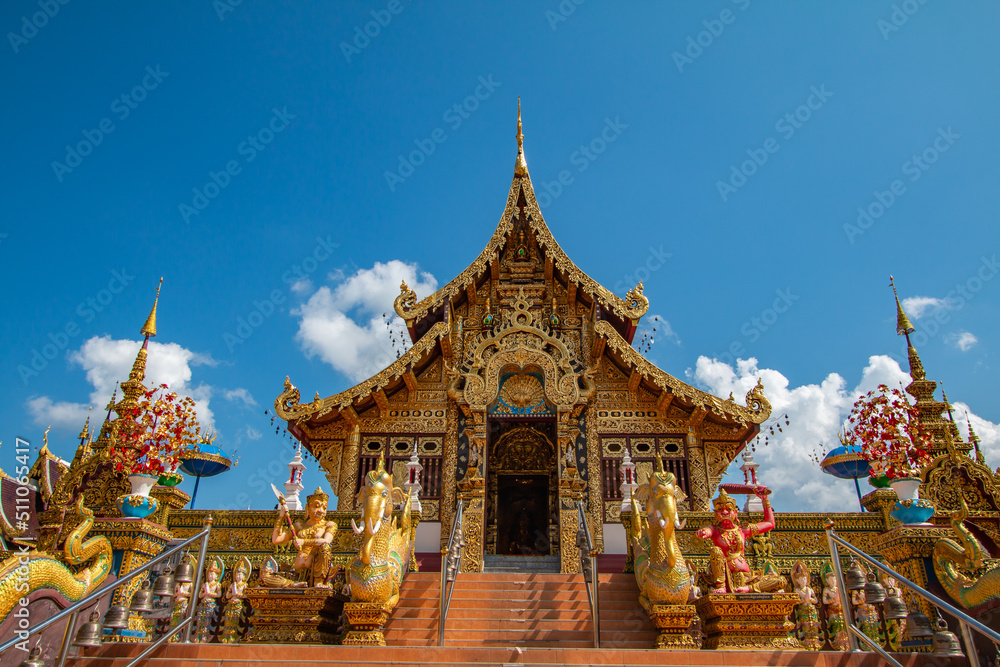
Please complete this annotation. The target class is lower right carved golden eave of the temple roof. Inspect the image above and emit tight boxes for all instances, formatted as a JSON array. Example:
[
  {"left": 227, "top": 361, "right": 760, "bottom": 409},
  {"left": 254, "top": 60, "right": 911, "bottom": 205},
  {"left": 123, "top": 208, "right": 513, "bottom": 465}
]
[{"left": 594, "top": 320, "right": 771, "bottom": 430}]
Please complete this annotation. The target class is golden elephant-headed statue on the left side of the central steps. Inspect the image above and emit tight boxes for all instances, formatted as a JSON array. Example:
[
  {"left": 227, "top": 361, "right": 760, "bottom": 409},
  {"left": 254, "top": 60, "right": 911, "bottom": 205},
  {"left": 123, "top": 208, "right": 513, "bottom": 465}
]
[{"left": 347, "top": 456, "right": 413, "bottom": 609}]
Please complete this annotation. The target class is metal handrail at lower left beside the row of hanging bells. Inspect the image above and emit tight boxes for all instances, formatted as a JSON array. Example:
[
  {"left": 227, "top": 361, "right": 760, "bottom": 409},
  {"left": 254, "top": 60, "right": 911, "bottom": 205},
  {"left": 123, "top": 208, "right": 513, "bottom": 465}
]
[{"left": 0, "top": 517, "right": 212, "bottom": 667}]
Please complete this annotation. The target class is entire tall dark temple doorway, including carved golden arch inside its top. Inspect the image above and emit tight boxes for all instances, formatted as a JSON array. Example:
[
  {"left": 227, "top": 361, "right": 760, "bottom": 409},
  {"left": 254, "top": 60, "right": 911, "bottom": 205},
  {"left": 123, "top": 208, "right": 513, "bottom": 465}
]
[{"left": 483, "top": 419, "right": 559, "bottom": 556}]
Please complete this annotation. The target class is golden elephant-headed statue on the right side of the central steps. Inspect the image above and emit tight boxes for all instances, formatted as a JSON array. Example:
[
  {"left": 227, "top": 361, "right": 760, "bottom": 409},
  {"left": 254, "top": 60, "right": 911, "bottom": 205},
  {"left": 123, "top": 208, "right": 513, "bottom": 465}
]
[{"left": 630, "top": 458, "right": 691, "bottom": 612}]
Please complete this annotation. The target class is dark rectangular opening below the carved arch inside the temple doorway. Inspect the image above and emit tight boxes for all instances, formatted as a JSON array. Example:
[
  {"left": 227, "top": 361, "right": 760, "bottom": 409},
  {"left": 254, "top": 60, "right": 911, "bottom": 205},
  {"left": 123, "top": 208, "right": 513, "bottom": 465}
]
[{"left": 496, "top": 474, "right": 549, "bottom": 556}]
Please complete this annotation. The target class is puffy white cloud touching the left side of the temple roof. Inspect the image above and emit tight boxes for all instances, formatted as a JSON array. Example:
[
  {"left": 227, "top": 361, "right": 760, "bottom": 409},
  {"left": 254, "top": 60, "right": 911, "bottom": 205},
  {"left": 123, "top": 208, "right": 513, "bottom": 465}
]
[{"left": 292, "top": 259, "right": 437, "bottom": 381}]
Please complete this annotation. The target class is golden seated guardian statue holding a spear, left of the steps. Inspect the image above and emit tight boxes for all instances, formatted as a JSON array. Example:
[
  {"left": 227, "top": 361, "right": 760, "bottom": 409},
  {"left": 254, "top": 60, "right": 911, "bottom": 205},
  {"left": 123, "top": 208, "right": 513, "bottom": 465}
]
[{"left": 271, "top": 487, "right": 337, "bottom": 588}]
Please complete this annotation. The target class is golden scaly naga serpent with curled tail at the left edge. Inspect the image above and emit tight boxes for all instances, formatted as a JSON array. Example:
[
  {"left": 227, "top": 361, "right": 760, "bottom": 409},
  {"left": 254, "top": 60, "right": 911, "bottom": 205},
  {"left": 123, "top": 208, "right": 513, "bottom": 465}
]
[{"left": 0, "top": 495, "right": 111, "bottom": 619}]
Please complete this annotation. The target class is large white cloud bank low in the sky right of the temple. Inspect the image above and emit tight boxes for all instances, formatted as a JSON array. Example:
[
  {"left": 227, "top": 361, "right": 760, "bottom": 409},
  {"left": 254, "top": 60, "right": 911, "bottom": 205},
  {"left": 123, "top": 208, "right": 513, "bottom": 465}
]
[{"left": 688, "top": 355, "right": 1000, "bottom": 512}]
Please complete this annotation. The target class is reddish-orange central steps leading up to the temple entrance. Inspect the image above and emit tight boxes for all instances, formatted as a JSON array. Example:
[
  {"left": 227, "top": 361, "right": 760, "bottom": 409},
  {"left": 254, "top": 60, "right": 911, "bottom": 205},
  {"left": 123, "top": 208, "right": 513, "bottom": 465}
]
[{"left": 385, "top": 572, "right": 656, "bottom": 648}]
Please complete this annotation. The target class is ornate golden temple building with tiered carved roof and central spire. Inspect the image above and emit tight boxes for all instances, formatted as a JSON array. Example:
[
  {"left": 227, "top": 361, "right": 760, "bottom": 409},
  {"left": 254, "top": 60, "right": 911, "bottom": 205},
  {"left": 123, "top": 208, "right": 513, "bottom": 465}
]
[{"left": 275, "top": 105, "right": 771, "bottom": 572}]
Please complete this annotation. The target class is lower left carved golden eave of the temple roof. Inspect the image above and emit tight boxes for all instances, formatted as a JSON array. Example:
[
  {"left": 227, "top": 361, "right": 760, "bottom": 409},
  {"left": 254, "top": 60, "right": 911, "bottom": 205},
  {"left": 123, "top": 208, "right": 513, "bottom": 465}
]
[{"left": 274, "top": 321, "right": 449, "bottom": 430}]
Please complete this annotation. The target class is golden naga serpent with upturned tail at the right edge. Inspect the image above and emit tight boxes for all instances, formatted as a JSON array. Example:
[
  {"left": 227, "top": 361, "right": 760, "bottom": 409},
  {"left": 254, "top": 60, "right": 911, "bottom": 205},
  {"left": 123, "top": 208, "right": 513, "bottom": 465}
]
[{"left": 931, "top": 499, "right": 1000, "bottom": 609}]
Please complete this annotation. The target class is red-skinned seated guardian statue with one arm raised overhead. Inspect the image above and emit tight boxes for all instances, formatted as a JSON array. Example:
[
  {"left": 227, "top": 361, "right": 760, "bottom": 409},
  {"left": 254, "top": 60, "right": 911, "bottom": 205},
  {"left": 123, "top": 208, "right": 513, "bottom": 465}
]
[{"left": 695, "top": 486, "right": 785, "bottom": 593}]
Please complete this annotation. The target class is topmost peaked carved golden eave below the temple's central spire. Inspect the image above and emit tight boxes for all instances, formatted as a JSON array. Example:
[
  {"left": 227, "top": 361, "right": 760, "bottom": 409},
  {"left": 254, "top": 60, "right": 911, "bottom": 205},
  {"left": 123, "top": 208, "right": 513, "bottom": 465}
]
[{"left": 394, "top": 146, "right": 649, "bottom": 342}]
